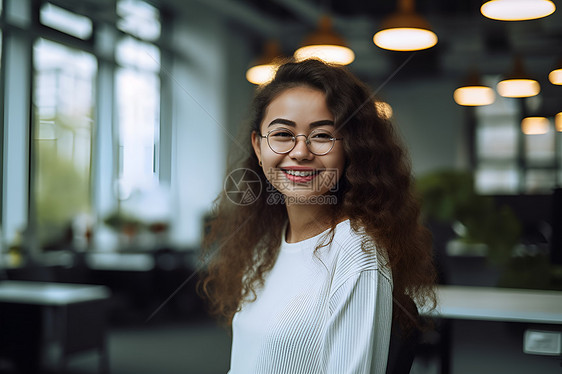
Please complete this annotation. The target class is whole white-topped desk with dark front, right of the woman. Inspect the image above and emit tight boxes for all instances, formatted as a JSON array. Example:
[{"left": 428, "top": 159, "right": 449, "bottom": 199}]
[{"left": 420, "top": 286, "right": 562, "bottom": 374}]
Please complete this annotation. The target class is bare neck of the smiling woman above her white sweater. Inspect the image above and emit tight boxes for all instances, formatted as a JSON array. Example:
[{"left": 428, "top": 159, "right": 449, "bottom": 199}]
[{"left": 286, "top": 204, "right": 333, "bottom": 243}]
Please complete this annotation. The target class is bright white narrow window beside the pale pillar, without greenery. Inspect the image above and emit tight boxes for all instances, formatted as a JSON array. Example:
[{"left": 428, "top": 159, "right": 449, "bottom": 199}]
[{"left": 115, "top": 0, "right": 160, "bottom": 199}]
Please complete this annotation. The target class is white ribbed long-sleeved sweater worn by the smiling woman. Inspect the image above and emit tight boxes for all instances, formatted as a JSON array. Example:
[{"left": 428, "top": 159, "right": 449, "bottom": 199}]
[{"left": 229, "top": 221, "right": 392, "bottom": 374}]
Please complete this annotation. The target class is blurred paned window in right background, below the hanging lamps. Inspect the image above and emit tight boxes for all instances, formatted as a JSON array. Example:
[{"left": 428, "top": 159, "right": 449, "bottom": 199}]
[{"left": 474, "top": 77, "right": 562, "bottom": 194}]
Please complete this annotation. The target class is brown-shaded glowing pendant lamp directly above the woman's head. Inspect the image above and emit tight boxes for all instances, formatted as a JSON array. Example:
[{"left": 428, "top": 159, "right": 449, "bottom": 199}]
[{"left": 295, "top": 16, "right": 355, "bottom": 65}]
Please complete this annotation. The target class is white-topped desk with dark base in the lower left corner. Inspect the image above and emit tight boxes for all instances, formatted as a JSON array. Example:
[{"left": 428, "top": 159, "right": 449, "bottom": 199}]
[{"left": 0, "top": 281, "right": 110, "bottom": 373}]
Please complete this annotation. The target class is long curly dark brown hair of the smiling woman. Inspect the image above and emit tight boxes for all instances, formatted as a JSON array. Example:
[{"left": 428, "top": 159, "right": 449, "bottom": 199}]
[{"left": 200, "top": 60, "right": 436, "bottom": 326}]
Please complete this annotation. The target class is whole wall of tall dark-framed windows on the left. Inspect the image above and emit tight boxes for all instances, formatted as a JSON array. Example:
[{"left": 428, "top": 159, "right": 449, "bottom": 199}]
[{"left": 0, "top": 0, "right": 161, "bottom": 250}]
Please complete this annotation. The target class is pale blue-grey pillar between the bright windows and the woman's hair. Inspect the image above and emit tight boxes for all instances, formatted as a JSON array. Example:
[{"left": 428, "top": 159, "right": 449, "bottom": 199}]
[{"left": 169, "top": 7, "right": 228, "bottom": 247}]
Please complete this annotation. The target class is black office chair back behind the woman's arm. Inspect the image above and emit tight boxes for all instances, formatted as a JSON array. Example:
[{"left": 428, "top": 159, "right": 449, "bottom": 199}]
[{"left": 386, "top": 297, "right": 421, "bottom": 374}]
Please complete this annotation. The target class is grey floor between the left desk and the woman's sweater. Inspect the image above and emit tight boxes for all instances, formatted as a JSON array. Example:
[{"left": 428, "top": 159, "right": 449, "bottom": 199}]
[{"left": 63, "top": 320, "right": 230, "bottom": 374}]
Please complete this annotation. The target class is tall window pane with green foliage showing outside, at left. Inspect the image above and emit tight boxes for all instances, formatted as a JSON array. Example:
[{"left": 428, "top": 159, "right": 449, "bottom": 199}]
[{"left": 32, "top": 39, "right": 97, "bottom": 248}]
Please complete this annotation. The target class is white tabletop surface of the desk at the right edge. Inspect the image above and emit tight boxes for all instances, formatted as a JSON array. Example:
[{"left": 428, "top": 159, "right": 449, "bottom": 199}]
[{"left": 422, "top": 286, "right": 562, "bottom": 324}]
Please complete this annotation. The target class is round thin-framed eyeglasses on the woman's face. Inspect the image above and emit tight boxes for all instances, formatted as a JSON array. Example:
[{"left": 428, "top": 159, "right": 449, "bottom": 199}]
[{"left": 260, "top": 128, "right": 343, "bottom": 156}]
